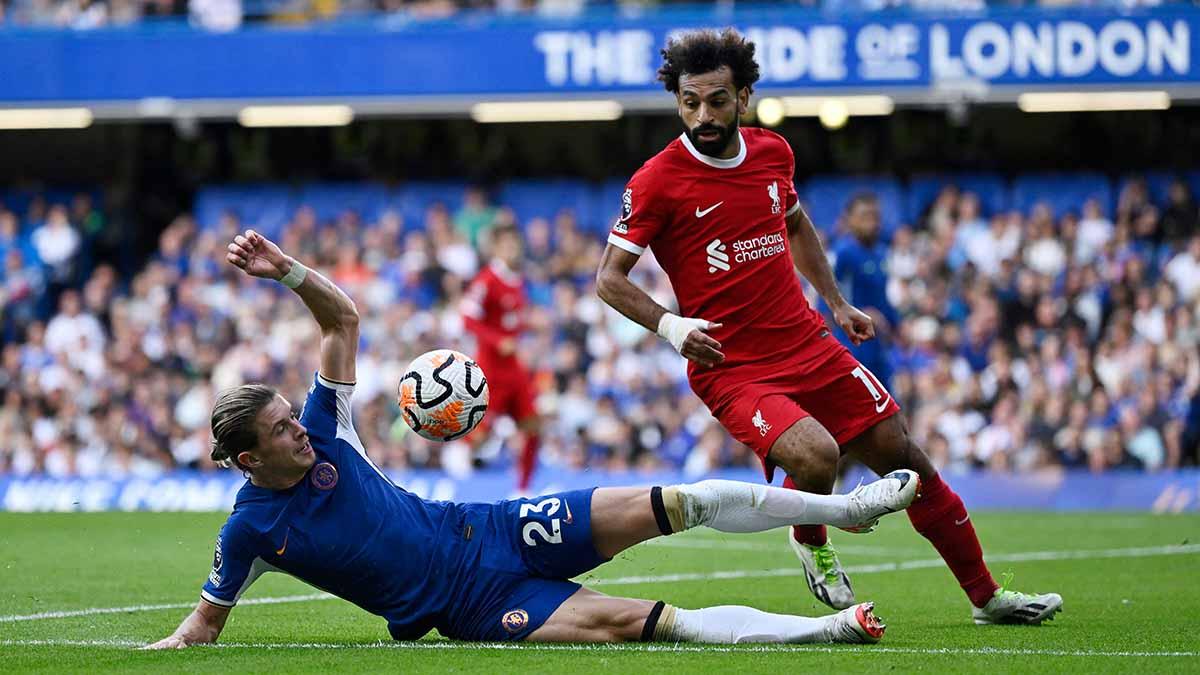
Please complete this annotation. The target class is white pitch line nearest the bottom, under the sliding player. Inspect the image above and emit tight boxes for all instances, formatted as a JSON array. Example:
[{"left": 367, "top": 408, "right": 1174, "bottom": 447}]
[{"left": 0, "top": 640, "right": 1200, "bottom": 657}]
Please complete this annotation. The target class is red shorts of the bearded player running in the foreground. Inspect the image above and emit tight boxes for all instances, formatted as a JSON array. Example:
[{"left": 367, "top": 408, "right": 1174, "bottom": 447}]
[{"left": 696, "top": 348, "right": 900, "bottom": 483}]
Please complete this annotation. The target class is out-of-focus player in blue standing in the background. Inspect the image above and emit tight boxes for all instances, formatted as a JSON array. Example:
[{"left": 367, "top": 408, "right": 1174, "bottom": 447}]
[{"left": 827, "top": 192, "right": 900, "bottom": 390}]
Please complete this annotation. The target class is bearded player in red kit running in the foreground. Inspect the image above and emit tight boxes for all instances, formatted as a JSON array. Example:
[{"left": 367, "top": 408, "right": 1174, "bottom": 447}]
[{"left": 596, "top": 29, "right": 1062, "bottom": 623}]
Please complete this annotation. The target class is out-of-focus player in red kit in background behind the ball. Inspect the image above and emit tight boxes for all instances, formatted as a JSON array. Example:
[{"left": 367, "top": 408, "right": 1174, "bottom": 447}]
[{"left": 462, "top": 226, "right": 540, "bottom": 491}]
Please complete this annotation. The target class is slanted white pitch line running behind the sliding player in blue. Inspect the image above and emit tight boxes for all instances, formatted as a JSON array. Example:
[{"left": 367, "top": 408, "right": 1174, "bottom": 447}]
[{"left": 0, "top": 544, "right": 1200, "bottom": 624}]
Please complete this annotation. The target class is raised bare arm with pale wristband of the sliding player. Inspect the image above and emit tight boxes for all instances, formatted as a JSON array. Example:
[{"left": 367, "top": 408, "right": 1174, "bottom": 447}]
[{"left": 226, "top": 229, "right": 359, "bottom": 382}]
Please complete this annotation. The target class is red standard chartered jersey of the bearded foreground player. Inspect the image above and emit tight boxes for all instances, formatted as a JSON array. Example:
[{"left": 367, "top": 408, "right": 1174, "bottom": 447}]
[{"left": 608, "top": 129, "right": 838, "bottom": 386}]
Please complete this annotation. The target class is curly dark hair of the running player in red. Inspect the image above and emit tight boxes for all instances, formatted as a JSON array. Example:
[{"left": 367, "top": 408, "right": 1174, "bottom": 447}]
[{"left": 659, "top": 28, "right": 758, "bottom": 94}]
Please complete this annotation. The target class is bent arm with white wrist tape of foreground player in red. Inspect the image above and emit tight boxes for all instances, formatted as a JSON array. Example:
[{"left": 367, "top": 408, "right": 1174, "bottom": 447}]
[{"left": 596, "top": 244, "right": 725, "bottom": 368}]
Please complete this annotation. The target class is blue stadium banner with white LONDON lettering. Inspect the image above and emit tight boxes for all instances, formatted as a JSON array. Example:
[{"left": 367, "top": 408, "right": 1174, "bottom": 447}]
[{"left": 0, "top": 5, "right": 1200, "bottom": 102}]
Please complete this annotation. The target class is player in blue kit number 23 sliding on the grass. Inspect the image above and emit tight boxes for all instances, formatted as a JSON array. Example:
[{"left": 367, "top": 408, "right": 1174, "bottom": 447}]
[{"left": 149, "top": 231, "right": 919, "bottom": 649}]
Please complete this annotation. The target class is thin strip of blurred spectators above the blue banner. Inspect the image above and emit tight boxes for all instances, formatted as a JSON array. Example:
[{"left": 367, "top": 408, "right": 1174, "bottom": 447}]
[{"left": 0, "top": 0, "right": 1192, "bottom": 30}]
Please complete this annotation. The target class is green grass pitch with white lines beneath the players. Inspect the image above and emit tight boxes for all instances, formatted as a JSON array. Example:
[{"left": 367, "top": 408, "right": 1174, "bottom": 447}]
[{"left": 0, "top": 513, "right": 1200, "bottom": 675}]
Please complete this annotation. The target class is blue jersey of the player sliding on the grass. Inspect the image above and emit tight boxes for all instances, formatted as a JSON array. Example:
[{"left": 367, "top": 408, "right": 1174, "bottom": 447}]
[{"left": 200, "top": 375, "right": 481, "bottom": 638}]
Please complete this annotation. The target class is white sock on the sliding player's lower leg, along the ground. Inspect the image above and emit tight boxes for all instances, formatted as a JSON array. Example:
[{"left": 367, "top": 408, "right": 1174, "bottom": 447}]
[{"left": 665, "top": 605, "right": 829, "bottom": 644}]
